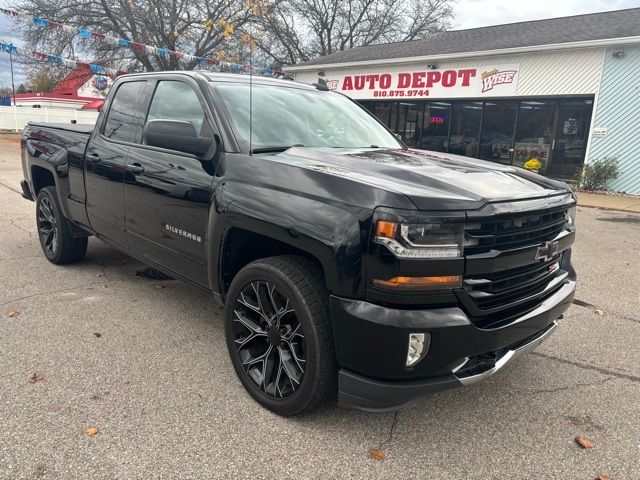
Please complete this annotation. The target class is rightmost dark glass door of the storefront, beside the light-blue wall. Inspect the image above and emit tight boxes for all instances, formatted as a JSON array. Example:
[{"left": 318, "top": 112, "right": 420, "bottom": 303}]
[{"left": 546, "top": 100, "right": 593, "bottom": 179}]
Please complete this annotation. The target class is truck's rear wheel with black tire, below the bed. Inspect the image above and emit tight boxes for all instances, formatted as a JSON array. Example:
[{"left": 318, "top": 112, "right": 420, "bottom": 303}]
[{"left": 36, "top": 187, "right": 88, "bottom": 265}]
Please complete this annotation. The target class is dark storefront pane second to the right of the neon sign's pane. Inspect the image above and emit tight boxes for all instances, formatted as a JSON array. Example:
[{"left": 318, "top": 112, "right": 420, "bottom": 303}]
[{"left": 479, "top": 100, "right": 518, "bottom": 164}]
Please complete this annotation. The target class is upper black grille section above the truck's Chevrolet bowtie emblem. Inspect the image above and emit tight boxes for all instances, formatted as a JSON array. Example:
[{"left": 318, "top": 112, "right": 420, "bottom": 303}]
[{"left": 464, "top": 208, "right": 567, "bottom": 255}]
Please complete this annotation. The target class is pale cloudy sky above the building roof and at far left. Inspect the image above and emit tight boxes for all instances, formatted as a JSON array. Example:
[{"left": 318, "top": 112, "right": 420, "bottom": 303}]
[{"left": 0, "top": 0, "right": 640, "bottom": 87}]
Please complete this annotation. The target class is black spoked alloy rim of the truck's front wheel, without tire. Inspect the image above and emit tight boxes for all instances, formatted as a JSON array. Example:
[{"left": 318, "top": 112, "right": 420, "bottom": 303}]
[{"left": 233, "top": 280, "right": 306, "bottom": 398}]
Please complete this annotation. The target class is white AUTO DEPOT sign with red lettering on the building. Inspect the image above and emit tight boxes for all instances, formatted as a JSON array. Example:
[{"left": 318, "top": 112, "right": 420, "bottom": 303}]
[{"left": 326, "top": 65, "right": 520, "bottom": 99}]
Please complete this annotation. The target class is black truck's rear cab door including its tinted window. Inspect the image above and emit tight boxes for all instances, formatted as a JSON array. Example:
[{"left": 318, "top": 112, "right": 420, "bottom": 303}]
[{"left": 85, "top": 80, "right": 148, "bottom": 248}]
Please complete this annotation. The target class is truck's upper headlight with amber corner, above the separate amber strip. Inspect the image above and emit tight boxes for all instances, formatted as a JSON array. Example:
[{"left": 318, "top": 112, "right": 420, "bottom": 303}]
[{"left": 373, "top": 220, "right": 464, "bottom": 258}]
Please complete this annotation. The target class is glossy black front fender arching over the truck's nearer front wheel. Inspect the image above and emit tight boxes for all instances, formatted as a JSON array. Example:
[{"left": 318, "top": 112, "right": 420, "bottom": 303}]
[{"left": 208, "top": 180, "right": 371, "bottom": 297}]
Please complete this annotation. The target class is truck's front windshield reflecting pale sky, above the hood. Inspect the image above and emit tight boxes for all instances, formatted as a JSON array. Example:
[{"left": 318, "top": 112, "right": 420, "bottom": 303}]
[{"left": 215, "top": 83, "right": 402, "bottom": 151}]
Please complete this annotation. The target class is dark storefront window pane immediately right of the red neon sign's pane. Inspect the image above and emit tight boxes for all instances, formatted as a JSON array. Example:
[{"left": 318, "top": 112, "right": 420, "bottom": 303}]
[{"left": 449, "top": 102, "right": 482, "bottom": 157}]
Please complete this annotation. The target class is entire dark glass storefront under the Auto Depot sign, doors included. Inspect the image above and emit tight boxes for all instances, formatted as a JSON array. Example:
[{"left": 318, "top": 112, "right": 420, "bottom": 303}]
[{"left": 361, "top": 98, "right": 593, "bottom": 178}]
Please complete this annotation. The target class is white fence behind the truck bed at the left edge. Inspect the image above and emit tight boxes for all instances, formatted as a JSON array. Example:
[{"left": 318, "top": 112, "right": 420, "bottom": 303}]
[{"left": 0, "top": 106, "right": 98, "bottom": 132}]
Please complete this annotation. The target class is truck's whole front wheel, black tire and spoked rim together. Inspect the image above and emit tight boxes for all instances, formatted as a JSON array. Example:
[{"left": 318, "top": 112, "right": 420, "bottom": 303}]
[{"left": 225, "top": 255, "right": 336, "bottom": 416}]
